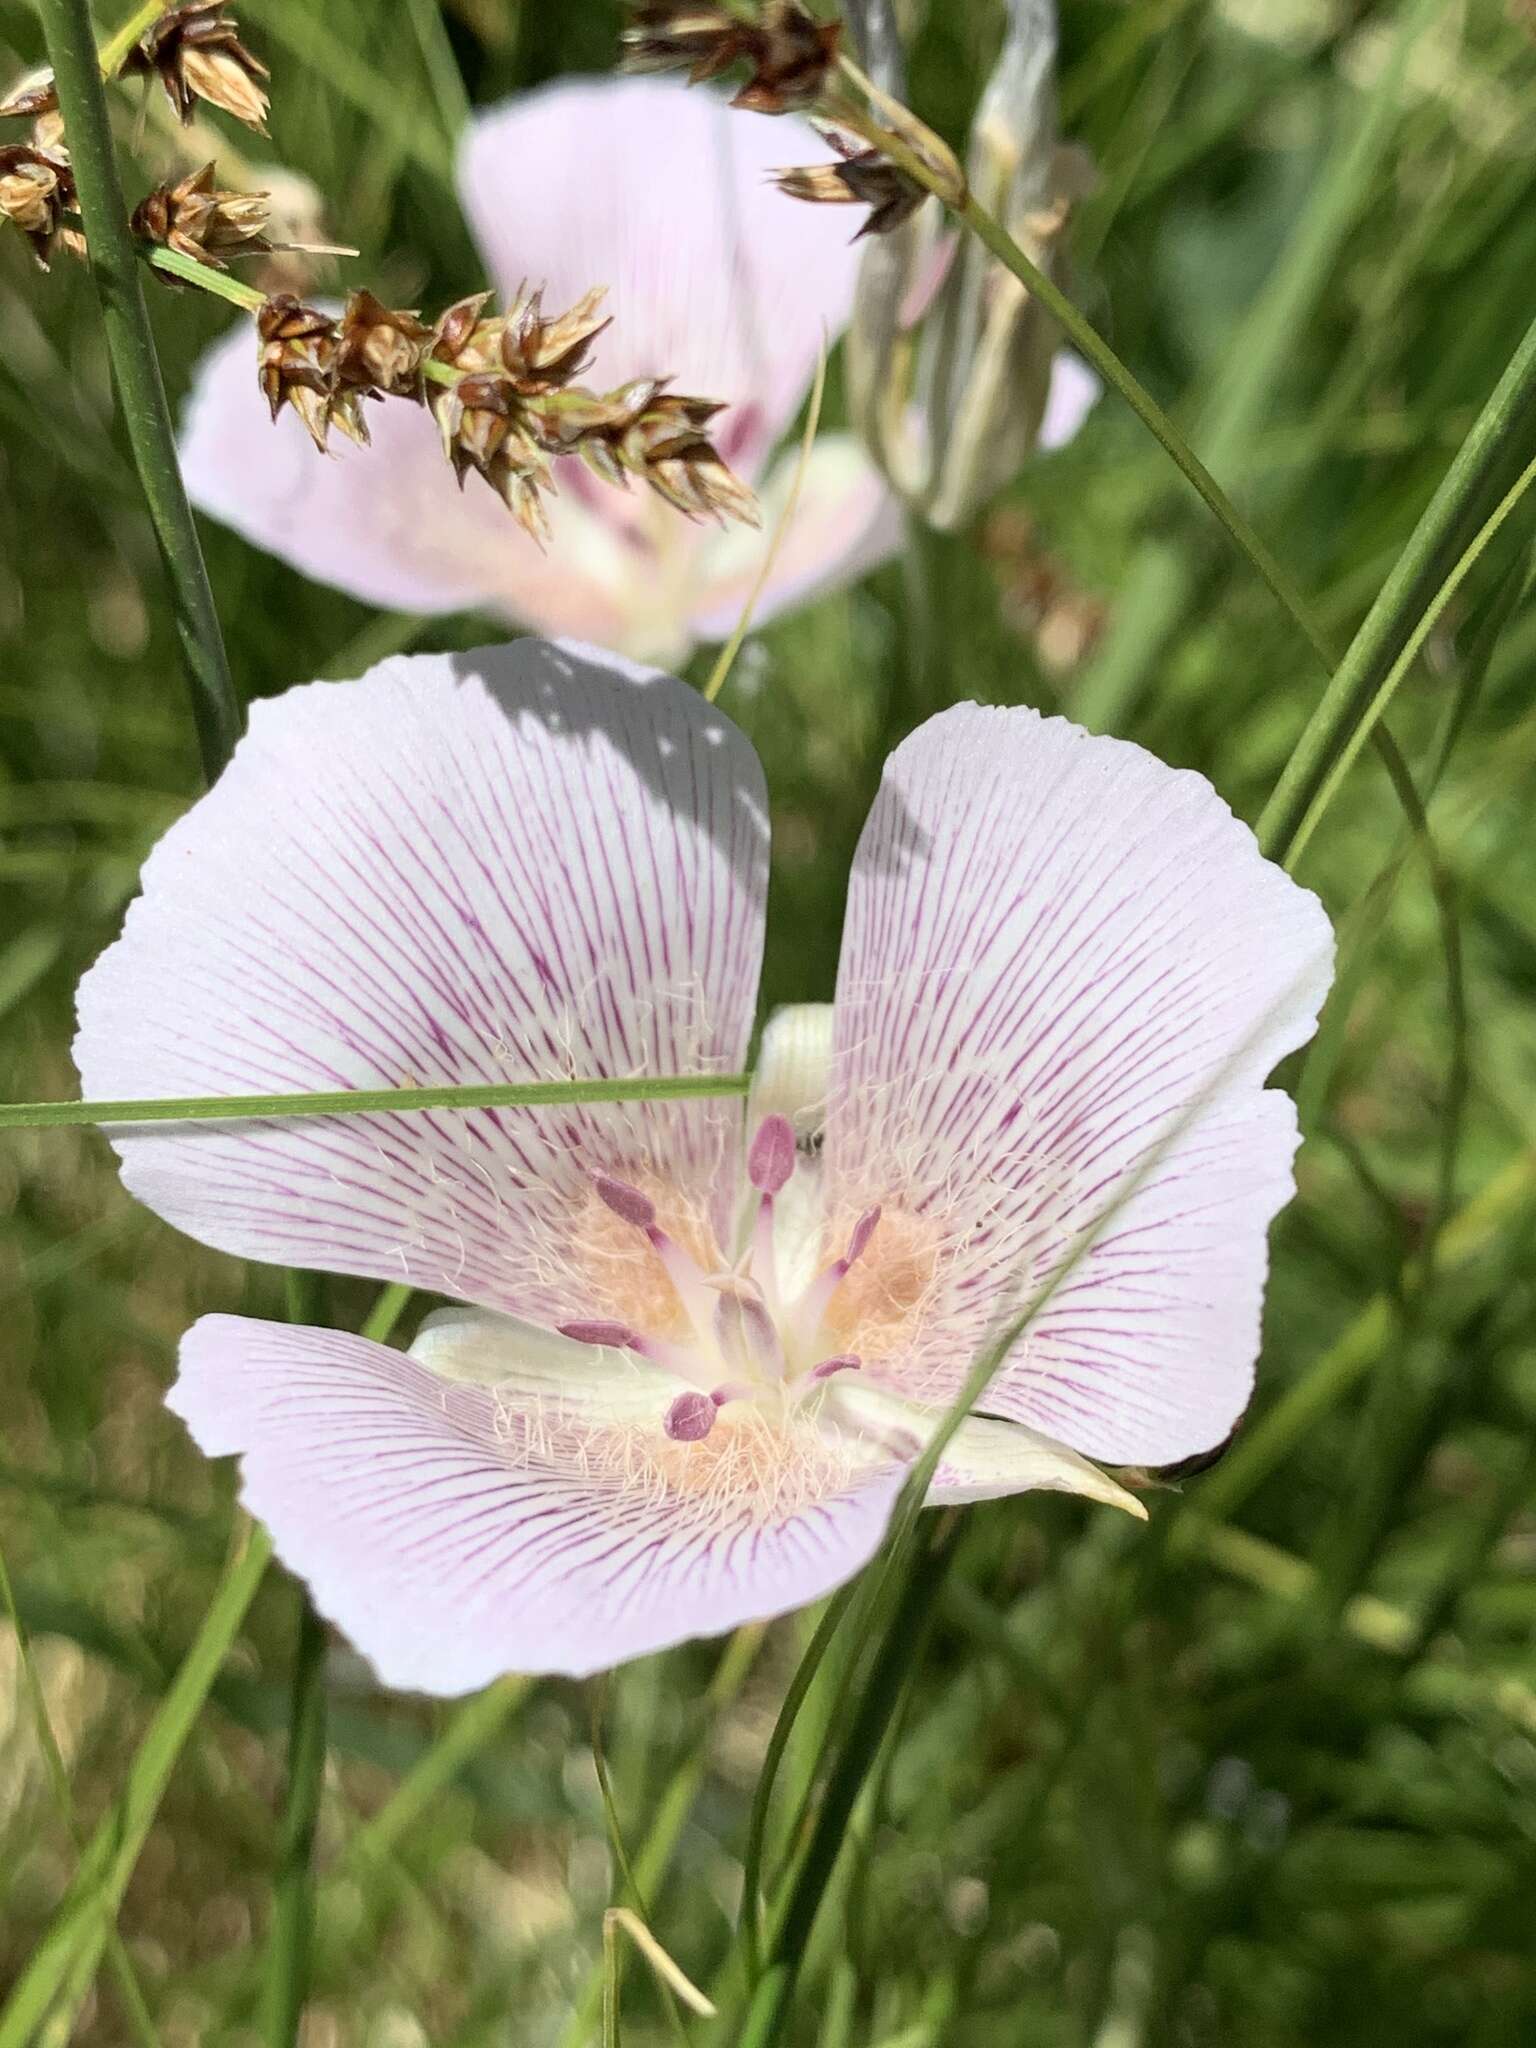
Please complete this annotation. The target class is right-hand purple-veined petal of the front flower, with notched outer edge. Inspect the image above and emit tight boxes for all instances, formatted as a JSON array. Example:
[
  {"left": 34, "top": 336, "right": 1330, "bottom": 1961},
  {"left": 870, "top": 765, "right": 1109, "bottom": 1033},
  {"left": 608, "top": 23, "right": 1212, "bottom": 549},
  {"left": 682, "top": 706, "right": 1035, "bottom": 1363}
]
[{"left": 823, "top": 705, "right": 1331, "bottom": 1462}]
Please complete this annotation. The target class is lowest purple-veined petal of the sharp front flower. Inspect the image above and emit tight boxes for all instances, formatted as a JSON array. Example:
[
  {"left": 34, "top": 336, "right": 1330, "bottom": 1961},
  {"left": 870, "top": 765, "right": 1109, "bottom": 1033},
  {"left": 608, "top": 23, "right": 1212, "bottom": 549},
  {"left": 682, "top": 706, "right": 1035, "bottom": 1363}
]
[{"left": 170, "top": 1315, "right": 901, "bottom": 1696}]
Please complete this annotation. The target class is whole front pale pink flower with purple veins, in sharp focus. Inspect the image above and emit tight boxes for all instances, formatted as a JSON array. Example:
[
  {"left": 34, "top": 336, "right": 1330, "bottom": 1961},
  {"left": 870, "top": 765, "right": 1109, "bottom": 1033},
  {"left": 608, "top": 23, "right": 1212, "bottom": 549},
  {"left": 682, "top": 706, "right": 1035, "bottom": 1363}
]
[{"left": 76, "top": 641, "right": 1331, "bottom": 1694}]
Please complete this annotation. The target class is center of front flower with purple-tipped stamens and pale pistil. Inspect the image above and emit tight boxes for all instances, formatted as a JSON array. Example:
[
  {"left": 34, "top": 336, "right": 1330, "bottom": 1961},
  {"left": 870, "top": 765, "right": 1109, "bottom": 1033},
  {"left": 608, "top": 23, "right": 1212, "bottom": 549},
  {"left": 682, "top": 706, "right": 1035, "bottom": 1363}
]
[{"left": 559, "top": 1116, "right": 881, "bottom": 1444}]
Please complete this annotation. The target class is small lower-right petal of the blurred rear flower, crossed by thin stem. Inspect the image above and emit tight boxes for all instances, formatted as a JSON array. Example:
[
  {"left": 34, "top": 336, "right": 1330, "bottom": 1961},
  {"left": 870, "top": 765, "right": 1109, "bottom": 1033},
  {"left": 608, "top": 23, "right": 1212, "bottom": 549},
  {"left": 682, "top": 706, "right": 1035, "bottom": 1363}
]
[{"left": 692, "top": 434, "right": 901, "bottom": 641}]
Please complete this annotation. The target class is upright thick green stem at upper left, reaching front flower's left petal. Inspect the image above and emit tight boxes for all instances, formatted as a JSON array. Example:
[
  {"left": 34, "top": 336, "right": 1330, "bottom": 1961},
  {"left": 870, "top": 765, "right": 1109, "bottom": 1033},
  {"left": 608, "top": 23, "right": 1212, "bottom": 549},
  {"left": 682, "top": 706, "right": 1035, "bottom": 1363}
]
[{"left": 39, "top": 0, "right": 240, "bottom": 780}]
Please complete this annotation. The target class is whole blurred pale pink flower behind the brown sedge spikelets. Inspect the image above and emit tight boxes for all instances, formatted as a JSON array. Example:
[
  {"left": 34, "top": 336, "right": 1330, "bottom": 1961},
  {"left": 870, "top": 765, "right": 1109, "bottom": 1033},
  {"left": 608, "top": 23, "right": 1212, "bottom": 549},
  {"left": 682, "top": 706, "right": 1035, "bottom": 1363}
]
[{"left": 182, "top": 78, "right": 1098, "bottom": 662}]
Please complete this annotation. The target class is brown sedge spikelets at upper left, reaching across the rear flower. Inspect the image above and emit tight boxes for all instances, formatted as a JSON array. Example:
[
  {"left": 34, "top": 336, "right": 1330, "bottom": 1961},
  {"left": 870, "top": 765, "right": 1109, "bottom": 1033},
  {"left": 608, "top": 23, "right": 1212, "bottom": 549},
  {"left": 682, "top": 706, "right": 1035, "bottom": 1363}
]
[{"left": 0, "top": 0, "right": 758, "bottom": 543}]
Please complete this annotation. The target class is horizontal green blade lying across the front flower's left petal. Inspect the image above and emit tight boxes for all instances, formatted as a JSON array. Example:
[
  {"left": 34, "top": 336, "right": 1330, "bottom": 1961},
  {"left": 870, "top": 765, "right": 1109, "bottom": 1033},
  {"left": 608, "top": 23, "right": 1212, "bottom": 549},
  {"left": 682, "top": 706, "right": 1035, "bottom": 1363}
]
[{"left": 0, "top": 1073, "right": 752, "bottom": 1130}]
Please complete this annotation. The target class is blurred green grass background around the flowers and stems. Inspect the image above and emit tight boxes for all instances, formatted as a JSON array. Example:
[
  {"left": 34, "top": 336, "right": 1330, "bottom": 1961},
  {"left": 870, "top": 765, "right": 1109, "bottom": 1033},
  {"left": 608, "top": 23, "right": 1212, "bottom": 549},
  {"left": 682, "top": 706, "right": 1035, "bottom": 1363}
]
[{"left": 0, "top": 0, "right": 1536, "bottom": 2048}]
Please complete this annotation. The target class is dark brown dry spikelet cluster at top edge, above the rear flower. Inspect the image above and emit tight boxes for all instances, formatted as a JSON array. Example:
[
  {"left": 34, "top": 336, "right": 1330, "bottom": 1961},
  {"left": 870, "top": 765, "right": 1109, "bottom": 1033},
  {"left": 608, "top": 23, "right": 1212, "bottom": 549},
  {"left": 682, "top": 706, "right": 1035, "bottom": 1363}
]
[{"left": 625, "top": 0, "right": 842, "bottom": 115}]
